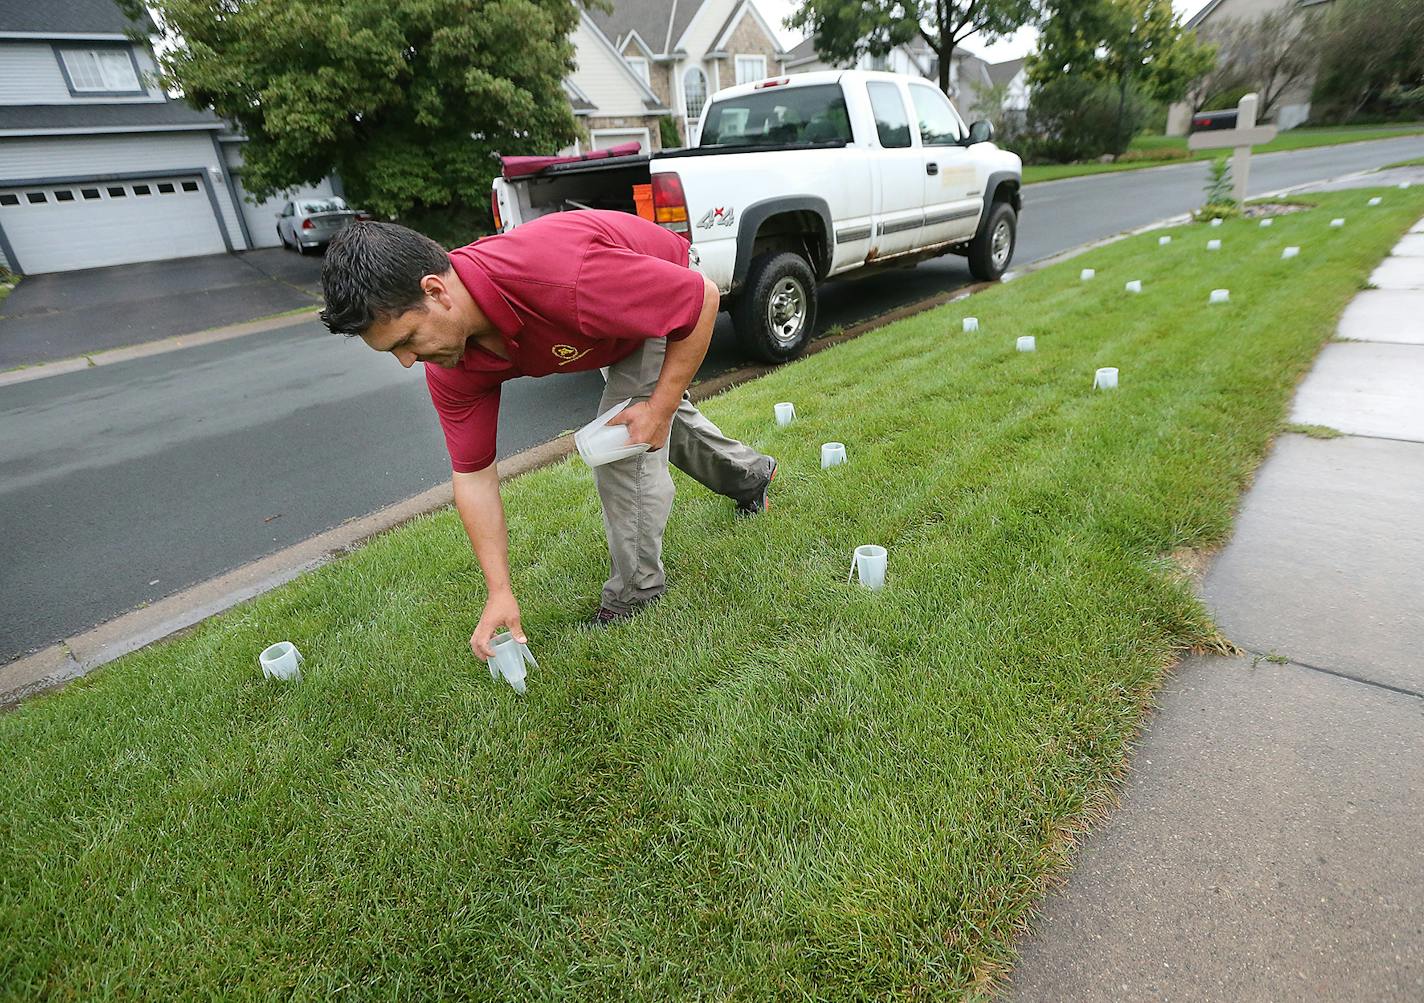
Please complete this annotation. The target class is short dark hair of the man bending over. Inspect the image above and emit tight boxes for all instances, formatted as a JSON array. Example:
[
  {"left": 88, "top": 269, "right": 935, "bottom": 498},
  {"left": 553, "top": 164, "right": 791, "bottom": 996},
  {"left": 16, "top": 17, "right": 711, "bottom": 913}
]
[{"left": 322, "top": 221, "right": 450, "bottom": 338}]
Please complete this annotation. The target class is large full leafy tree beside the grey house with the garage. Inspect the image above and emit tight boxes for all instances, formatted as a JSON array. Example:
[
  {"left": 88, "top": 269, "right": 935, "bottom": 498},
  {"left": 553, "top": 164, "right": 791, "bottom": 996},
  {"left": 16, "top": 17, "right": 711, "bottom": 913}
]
[{"left": 120, "top": 0, "right": 578, "bottom": 242}]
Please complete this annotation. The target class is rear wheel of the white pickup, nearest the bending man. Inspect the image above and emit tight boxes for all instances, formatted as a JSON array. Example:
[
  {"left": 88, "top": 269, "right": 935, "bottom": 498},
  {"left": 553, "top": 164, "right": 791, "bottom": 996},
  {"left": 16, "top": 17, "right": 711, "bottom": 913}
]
[{"left": 732, "top": 251, "right": 816, "bottom": 362}]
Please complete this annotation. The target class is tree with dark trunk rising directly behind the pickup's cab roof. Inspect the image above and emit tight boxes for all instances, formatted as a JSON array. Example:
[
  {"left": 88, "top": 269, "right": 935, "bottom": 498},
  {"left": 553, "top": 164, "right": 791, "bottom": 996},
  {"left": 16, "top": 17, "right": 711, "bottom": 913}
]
[{"left": 786, "top": 0, "right": 1037, "bottom": 93}]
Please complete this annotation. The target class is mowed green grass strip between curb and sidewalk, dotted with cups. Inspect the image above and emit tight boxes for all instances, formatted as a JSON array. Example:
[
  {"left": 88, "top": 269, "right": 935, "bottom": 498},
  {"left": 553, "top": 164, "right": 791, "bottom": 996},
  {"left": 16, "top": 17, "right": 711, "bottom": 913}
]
[{"left": 0, "top": 189, "right": 1424, "bottom": 1000}]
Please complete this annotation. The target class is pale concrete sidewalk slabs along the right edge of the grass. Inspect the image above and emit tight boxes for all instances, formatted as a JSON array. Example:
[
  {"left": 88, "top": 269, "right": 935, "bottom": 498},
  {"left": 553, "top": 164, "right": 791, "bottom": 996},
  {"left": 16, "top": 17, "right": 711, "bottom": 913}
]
[{"left": 1011, "top": 209, "right": 1424, "bottom": 1002}]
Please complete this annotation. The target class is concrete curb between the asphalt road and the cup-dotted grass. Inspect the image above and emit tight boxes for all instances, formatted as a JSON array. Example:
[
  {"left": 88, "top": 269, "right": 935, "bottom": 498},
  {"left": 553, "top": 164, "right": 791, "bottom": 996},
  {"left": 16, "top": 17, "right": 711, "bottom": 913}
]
[{"left": 0, "top": 171, "right": 1401, "bottom": 710}]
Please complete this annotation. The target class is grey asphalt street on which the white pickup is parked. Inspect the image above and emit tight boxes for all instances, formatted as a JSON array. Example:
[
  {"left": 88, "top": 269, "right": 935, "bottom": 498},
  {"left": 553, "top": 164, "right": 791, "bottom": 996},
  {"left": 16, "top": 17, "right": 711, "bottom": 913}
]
[{"left": 0, "top": 137, "right": 1424, "bottom": 664}]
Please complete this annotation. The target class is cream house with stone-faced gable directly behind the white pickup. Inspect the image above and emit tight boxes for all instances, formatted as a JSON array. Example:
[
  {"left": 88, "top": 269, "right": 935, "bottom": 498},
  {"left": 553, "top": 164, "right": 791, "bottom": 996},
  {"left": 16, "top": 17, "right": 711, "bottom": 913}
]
[{"left": 574, "top": 0, "right": 786, "bottom": 145}]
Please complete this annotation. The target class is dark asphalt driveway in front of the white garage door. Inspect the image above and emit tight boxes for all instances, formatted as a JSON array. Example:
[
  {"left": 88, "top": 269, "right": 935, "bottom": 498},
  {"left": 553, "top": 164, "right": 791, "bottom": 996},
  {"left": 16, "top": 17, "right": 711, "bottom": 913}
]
[{"left": 0, "top": 248, "right": 322, "bottom": 372}]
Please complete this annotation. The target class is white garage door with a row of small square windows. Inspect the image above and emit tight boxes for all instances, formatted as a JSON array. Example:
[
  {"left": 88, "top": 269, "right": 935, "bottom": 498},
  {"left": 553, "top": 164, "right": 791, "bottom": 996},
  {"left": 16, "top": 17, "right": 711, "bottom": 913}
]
[{"left": 0, "top": 175, "right": 226, "bottom": 275}]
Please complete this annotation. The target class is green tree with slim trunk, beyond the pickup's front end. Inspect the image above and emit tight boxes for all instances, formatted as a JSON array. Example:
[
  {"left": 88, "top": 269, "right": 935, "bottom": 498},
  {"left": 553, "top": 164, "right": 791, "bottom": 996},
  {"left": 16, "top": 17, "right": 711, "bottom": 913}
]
[{"left": 1028, "top": 0, "right": 1216, "bottom": 150}]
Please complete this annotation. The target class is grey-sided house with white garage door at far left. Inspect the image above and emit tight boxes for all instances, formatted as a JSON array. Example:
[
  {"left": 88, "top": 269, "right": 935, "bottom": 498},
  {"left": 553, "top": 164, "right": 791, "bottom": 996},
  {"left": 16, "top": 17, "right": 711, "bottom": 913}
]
[{"left": 0, "top": 0, "right": 333, "bottom": 274}]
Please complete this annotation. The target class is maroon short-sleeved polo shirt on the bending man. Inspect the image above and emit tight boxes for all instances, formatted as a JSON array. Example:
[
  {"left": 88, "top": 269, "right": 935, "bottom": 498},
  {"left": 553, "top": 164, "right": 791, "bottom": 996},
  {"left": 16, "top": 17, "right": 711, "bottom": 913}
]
[{"left": 426, "top": 209, "right": 705, "bottom": 473}]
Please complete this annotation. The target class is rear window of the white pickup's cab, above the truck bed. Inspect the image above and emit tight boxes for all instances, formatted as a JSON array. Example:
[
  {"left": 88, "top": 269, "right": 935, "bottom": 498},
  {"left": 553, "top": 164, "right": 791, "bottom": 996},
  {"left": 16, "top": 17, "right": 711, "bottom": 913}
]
[{"left": 699, "top": 84, "right": 850, "bottom": 147}]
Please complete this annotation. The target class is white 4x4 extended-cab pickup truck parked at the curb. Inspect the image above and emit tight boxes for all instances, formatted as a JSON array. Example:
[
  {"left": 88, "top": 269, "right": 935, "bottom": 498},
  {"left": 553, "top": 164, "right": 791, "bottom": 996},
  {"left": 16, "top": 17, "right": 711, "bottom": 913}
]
[{"left": 491, "top": 70, "right": 1022, "bottom": 362}]
